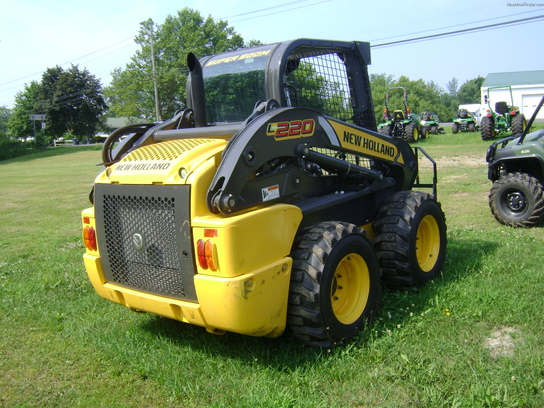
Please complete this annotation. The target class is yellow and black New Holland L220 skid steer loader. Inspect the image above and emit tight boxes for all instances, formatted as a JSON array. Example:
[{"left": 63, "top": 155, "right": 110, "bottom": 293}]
[{"left": 82, "top": 39, "right": 446, "bottom": 347}]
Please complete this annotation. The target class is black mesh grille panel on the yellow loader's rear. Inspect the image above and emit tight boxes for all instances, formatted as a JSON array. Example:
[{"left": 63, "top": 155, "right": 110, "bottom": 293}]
[{"left": 96, "top": 185, "right": 196, "bottom": 300}]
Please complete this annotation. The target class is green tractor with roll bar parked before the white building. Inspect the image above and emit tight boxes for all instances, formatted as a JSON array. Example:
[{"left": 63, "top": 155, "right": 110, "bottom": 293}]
[{"left": 480, "top": 86, "right": 527, "bottom": 140}]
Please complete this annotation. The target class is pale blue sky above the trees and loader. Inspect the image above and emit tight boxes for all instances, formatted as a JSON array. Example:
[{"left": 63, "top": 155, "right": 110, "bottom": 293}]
[{"left": 0, "top": 0, "right": 544, "bottom": 108}]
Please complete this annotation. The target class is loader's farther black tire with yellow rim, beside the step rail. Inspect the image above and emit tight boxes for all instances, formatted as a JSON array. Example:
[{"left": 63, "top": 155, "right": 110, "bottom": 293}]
[{"left": 373, "top": 191, "right": 447, "bottom": 286}]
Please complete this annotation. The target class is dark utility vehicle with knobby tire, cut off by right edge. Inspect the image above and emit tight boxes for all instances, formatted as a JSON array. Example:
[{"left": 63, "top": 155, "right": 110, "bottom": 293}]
[{"left": 486, "top": 97, "right": 544, "bottom": 227}]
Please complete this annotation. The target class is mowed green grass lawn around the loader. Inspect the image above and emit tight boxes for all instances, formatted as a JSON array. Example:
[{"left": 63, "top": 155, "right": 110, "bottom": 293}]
[{"left": 0, "top": 129, "right": 544, "bottom": 407}]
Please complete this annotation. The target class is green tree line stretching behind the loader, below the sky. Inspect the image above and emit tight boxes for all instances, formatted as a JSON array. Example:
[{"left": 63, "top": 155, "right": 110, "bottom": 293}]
[{"left": 0, "top": 8, "right": 484, "bottom": 151}]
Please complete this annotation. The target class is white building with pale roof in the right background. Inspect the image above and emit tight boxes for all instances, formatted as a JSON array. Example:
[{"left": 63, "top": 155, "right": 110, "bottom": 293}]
[{"left": 481, "top": 70, "right": 544, "bottom": 120}]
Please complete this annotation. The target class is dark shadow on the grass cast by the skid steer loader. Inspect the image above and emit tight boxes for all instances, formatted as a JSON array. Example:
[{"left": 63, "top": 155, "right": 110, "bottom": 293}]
[{"left": 137, "top": 234, "right": 497, "bottom": 371}]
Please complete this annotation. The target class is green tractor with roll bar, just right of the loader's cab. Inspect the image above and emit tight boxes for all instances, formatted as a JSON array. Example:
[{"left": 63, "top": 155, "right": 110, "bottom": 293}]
[{"left": 378, "top": 86, "right": 426, "bottom": 143}]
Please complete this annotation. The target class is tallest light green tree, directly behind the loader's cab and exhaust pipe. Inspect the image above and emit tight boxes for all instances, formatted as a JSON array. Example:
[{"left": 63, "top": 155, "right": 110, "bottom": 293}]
[{"left": 105, "top": 8, "right": 246, "bottom": 119}]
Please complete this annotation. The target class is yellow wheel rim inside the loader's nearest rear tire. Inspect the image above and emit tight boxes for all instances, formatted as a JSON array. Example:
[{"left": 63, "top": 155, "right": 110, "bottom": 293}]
[{"left": 331, "top": 253, "right": 370, "bottom": 324}]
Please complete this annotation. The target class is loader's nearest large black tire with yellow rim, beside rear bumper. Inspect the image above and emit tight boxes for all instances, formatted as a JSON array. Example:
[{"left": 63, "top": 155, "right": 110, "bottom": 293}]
[{"left": 287, "top": 222, "right": 381, "bottom": 348}]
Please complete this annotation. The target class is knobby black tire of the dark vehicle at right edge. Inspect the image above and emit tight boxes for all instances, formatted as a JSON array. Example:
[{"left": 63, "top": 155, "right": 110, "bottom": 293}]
[{"left": 489, "top": 173, "right": 544, "bottom": 227}]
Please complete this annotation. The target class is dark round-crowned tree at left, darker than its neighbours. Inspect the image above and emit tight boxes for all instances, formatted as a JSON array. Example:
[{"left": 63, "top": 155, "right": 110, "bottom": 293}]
[{"left": 34, "top": 65, "right": 107, "bottom": 137}]
